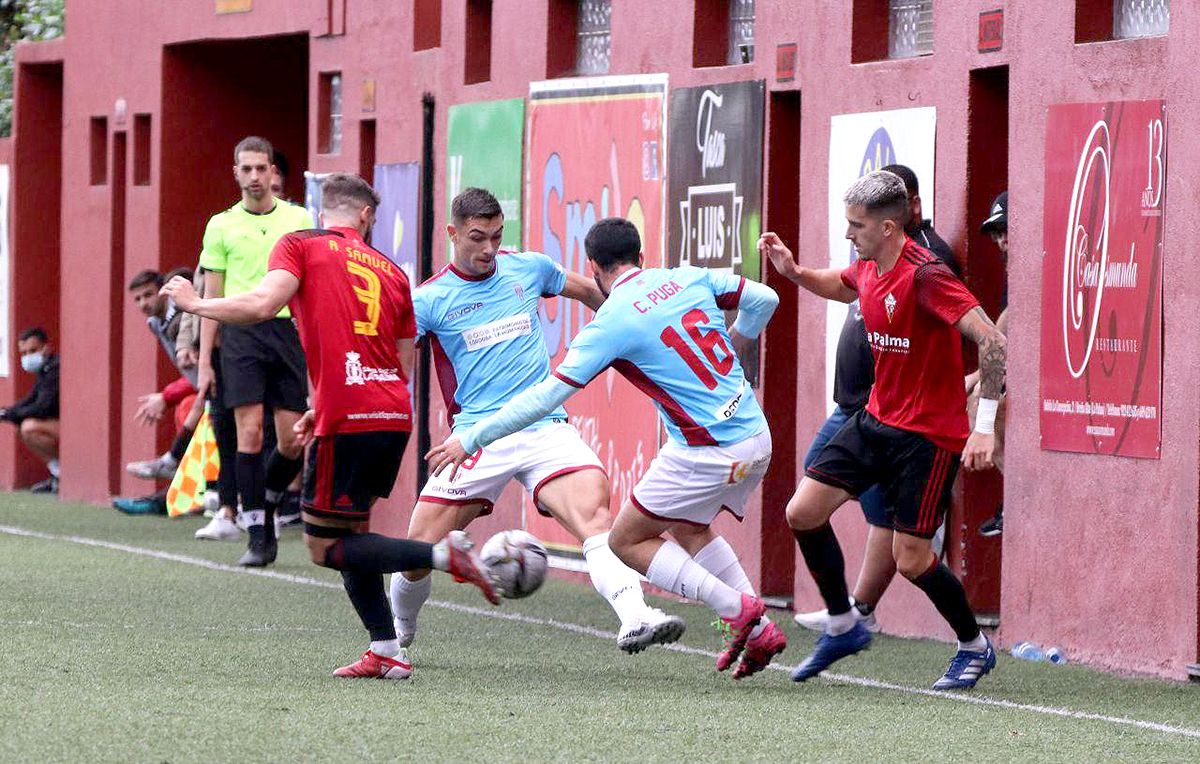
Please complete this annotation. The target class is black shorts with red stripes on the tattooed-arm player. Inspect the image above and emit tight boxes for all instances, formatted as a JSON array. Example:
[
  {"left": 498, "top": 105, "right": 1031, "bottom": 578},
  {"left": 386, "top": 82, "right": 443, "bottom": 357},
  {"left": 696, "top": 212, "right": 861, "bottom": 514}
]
[{"left": 805, "top": 409, "right": 961, "bottom": 539}]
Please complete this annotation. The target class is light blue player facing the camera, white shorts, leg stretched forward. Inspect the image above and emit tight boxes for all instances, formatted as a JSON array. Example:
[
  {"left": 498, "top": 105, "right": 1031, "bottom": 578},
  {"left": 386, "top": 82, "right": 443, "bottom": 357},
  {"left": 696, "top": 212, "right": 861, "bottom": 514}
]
[{"left": 391, "top": 188, "right": 684, "bottom": 671}]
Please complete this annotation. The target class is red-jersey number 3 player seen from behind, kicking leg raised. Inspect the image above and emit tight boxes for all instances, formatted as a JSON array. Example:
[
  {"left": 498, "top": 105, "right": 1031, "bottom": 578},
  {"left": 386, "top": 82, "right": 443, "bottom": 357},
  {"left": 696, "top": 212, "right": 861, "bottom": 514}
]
[{"left": 163, "top": 174, "right": 498, "bottom": 679}]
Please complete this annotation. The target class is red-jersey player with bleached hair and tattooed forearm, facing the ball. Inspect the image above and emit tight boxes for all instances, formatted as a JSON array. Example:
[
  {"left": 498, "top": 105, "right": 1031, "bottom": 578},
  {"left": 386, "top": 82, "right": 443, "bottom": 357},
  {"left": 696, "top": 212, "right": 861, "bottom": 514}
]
[{"left": 758, "top": 172, "right": 1006, "bottom": 690}]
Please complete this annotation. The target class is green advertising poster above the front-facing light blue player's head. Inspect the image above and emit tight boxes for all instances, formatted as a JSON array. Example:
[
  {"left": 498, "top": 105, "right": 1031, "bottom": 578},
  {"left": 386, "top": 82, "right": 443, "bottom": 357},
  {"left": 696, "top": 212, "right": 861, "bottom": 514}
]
[{"left": 446, "top": 98, "right": 524, "bottom": 247}]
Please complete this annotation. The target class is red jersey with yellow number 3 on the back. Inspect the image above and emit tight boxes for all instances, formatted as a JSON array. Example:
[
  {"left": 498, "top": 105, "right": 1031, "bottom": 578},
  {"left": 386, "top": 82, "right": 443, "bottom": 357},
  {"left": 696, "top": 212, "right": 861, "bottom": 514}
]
[{"left": 268, "top": 228, "right": 416, "bottom": 437}]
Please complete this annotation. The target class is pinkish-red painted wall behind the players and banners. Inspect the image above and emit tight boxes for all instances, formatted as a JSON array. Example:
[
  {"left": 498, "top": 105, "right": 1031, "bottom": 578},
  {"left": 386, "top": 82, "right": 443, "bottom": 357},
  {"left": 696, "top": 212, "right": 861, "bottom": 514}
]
[{"left": 0, "top": 0, "right": 1200, "bottom": 678}]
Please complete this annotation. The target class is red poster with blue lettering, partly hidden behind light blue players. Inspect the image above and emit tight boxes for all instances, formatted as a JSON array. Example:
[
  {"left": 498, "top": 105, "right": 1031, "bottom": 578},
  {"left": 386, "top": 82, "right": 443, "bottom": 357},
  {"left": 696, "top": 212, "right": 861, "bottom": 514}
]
[{"left": 524, "top": 74, "right": 667, "bottom": 548}]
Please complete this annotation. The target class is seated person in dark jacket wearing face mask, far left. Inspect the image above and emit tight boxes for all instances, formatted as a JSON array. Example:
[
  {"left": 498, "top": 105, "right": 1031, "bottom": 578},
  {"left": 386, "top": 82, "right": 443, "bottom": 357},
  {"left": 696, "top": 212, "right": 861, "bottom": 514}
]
[{"left": 0, "top": 326, "right": 59, "bottom": 493}]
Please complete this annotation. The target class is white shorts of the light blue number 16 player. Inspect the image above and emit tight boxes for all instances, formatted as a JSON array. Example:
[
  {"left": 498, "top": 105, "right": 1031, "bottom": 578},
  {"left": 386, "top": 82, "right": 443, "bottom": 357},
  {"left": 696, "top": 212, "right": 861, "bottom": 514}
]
[{"left": 630, "top": 427, "right": 770, "bottom": 528}]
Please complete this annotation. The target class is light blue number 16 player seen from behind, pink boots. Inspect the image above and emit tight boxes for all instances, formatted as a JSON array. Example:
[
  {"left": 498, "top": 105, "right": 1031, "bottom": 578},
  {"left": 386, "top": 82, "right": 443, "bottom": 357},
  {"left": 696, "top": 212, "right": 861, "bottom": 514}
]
[{"left": 430, "top": 218, "right": 787, "bottom": 679}]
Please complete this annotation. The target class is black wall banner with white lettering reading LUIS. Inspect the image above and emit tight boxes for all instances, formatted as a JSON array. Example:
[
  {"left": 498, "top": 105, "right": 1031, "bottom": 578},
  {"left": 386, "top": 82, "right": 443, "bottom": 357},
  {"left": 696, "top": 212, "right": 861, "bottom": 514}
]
[{"left": 667, "top": 80, "right": 764, "bottom": 281}]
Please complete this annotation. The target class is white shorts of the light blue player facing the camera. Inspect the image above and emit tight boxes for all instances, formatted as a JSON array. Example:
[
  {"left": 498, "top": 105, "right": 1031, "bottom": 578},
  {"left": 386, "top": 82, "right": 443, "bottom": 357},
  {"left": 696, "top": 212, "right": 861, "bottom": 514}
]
[{"left": 419, "top": 422, "right": 604, "bottom": 517}]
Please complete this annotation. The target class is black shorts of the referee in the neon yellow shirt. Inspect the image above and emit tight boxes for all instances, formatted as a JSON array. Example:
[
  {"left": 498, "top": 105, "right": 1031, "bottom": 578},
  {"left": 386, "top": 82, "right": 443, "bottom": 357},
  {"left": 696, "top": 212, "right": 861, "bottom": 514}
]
[{"left": 221, "top": 318, "right": 308, "bottom": 411}]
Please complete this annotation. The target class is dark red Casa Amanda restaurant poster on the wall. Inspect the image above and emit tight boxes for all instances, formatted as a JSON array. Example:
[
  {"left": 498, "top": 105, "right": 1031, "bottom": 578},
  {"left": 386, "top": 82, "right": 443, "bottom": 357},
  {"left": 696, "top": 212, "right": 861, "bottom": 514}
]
[{"left": 1040, "top": 101, "right": 1166, "bottom": 459}]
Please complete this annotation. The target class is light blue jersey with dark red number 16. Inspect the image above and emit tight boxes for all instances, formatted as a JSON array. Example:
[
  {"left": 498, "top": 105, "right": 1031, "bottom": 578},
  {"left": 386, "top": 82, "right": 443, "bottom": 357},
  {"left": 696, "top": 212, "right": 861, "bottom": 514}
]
[{"left": 554, "top": 266, "right": 767, "bottom": 446}]
